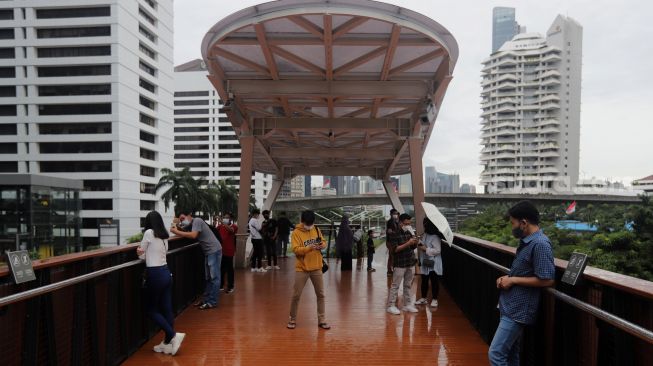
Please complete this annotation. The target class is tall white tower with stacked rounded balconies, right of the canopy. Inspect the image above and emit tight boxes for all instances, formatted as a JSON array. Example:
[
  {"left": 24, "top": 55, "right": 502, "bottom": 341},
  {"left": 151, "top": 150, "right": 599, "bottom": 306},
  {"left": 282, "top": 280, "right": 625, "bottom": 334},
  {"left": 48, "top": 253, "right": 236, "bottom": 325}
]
[{"left": 481, "top": 15, "right": 583, "bottom": 193}]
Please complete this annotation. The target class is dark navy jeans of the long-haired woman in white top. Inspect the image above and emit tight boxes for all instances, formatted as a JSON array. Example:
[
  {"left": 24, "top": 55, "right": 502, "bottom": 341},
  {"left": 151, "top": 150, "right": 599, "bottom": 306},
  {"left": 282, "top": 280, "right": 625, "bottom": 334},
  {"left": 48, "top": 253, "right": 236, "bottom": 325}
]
[{"left": 145, "top": 266, "right": 175, "bottom": 343}]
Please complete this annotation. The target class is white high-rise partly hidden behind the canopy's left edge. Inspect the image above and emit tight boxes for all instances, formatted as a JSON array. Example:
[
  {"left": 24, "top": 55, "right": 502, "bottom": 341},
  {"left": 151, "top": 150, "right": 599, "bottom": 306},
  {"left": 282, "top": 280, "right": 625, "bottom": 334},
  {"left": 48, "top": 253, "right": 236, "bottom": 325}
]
[{"left": 174, "top": 59, "right": 272, "bottom": 207}]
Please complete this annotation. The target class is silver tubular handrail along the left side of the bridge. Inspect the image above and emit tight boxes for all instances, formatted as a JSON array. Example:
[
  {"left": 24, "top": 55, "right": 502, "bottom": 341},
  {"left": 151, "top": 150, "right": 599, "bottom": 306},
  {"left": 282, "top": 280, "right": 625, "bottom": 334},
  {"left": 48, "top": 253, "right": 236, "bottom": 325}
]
[{"left": 0, "top": 243, "right": 199, "bottom": 307}]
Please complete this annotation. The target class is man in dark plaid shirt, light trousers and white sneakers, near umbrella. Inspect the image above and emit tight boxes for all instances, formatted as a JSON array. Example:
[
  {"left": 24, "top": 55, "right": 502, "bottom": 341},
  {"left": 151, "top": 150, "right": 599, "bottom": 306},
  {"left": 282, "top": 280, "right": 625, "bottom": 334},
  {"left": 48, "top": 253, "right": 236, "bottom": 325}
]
[{"left": 387, "top": 214, "right": 418, "bottom": 315}]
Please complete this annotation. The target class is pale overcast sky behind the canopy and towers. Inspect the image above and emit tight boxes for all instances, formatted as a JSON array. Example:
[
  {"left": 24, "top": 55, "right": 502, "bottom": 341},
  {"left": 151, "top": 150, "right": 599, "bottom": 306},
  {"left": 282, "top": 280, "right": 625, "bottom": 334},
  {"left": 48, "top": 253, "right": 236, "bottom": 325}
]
[{"left": 174, "top": 0, "right": 653, "bottom": 189}]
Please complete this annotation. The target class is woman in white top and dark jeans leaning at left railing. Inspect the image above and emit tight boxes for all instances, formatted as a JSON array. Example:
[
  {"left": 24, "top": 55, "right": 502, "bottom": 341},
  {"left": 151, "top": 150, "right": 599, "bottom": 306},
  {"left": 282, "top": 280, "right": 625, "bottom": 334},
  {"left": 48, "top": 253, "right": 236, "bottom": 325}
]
[{"left": 136, "top": 211, "right": 186, "bottom": 355}]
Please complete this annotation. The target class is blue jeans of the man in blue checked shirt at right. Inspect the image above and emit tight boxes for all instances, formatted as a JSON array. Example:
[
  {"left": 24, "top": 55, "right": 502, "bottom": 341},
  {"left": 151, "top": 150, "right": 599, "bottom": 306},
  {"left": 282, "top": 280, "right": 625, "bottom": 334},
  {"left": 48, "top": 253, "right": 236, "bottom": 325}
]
[{"left": 488, "top": 315, "right": 524, "bottom": 366}]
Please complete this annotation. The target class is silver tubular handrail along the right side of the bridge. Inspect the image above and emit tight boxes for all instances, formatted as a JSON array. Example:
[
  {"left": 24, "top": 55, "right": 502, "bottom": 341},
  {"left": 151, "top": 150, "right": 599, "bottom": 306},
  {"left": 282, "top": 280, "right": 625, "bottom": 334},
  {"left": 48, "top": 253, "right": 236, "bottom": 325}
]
[{"left": 451, "top": 240, "right": 653, "bottom": 344}]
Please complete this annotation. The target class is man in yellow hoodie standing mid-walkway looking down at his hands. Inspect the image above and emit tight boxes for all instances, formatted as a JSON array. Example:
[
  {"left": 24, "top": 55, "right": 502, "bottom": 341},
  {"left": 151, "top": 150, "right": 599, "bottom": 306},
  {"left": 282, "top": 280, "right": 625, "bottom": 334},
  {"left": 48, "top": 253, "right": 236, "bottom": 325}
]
[{"left": 287, "top": 210, "right": 331, "bottom": 329}]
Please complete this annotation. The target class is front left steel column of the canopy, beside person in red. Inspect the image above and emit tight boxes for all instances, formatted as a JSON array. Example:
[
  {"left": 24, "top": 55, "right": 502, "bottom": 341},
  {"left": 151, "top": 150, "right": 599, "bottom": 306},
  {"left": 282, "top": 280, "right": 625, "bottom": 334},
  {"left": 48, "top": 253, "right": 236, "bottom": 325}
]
[{"left": 235, "top": 135, "right": 254, "bottom": 268}]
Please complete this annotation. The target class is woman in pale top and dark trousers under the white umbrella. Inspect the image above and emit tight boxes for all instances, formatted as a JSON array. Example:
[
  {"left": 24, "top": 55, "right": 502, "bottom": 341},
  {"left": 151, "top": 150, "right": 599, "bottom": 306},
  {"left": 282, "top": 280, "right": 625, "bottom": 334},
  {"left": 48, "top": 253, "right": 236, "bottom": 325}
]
[{"left": 415, "top": 218, "right": 443, "bottom": 307}]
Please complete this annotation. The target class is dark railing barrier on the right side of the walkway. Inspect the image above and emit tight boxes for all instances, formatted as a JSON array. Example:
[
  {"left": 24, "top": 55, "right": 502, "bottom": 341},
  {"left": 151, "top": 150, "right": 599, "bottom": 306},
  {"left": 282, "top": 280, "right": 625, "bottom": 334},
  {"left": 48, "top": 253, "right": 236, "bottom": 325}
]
[{"left": 442, "top": 235, "right": 653, "bottom": 366}]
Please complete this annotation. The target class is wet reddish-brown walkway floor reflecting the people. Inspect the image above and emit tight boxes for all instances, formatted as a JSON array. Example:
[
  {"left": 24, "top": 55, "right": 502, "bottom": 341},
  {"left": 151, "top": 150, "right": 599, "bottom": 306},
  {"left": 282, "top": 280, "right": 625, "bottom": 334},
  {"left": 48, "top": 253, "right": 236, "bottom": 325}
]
[{"left": 124, "top": 247, "right": 488, "bottom": 365}]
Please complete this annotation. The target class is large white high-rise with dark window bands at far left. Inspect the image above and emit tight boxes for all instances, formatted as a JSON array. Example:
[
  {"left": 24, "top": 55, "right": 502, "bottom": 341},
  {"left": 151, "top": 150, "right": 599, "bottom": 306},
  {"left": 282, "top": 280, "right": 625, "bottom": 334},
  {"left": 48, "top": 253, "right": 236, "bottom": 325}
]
[{"left": 0, "top": 0, "right": 173, "bottom": 246}]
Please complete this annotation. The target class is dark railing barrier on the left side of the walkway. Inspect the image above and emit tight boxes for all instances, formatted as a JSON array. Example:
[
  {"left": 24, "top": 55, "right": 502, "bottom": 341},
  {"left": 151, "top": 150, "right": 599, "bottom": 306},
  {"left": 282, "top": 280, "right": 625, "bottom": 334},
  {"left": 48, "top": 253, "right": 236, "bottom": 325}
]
[{"left": 0, "top": 240, "right": 205, "bottom": 365}]
